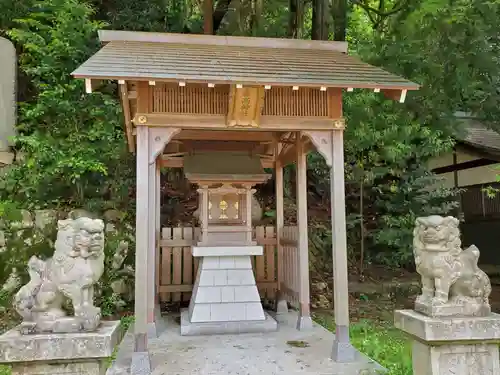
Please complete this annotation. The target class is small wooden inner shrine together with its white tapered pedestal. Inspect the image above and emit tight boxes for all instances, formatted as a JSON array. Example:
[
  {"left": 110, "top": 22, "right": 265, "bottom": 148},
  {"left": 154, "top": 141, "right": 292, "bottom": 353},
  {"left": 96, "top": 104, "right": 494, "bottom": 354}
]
[{"left": 181, "top": 151, "right": 277, "bottom": 335}]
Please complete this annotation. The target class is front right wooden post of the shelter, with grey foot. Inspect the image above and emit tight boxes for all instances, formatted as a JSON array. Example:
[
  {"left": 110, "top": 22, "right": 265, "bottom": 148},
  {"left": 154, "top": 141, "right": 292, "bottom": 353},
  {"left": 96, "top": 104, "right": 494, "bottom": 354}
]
[{"left": 330, "top": 130, "right": 356, "bottom": 362}]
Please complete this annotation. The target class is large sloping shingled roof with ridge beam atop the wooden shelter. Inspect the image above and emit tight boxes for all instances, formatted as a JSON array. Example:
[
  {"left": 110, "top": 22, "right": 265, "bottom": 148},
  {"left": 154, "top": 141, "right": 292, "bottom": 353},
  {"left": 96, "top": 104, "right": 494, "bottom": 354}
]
[{"left": 72, "top": 31, "right": 419, "bottom": 90}]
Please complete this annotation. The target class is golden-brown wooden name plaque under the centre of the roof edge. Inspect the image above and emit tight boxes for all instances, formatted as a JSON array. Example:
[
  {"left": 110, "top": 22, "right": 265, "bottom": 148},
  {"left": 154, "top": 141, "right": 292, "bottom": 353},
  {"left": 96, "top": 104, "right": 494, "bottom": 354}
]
[{"left": 227, "top": 85, "right": 265, "bottom": 127}]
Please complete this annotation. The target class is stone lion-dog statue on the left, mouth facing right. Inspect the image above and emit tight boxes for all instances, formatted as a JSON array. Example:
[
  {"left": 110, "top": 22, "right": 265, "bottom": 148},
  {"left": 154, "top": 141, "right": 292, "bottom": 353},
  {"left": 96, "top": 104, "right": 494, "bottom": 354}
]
[{"left": 14, "top": 217, "right": 104, "bottom": 334}]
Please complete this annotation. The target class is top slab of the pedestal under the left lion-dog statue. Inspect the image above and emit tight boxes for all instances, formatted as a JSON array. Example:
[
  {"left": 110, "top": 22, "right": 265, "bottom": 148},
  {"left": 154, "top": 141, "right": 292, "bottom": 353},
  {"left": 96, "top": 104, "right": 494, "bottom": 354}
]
[{"left": 0, "top": 321, "right": 121, "bottom": 363}]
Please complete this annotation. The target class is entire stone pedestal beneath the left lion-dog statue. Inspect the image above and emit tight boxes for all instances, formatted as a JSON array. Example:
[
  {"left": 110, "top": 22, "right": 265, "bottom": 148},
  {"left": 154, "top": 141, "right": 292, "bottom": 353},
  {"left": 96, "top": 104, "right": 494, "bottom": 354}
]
[{"left": 0, "top": 321, "right": 121, "bottom": 375}]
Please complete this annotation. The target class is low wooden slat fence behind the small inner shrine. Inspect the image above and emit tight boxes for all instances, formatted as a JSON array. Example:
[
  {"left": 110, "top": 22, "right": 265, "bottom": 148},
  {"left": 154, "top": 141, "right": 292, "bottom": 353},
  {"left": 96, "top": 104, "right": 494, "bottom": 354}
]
[{"left": 156, "top": 226, "right": 299, "bottom": 305}]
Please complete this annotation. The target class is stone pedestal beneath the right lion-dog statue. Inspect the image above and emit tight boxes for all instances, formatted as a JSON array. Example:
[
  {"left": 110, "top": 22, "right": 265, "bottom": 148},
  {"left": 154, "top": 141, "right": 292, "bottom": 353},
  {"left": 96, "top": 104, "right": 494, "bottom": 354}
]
[{"left": 394, "top": 310, "right": 500, "bottom": 375}]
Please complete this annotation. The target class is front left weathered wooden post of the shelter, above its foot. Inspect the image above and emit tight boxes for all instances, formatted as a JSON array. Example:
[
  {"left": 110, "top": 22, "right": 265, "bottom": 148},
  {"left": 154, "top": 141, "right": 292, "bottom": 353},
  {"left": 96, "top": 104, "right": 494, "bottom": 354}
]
[{"left": 134, "top": 126, "right": 149, "bottom": 352}]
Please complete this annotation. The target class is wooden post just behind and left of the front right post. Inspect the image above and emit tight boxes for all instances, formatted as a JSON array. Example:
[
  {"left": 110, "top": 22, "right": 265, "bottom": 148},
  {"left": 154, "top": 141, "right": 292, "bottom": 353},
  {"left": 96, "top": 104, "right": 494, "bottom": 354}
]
[{"left": 295, "top": 132, "right": 312, "bottom": 330}]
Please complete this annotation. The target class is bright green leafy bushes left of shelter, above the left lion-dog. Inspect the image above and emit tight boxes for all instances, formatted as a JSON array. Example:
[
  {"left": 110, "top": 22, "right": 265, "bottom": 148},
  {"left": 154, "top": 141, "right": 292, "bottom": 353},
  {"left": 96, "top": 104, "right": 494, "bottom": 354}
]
[{"left": 2, "top": 0, "right": 131, "bottom": 212}]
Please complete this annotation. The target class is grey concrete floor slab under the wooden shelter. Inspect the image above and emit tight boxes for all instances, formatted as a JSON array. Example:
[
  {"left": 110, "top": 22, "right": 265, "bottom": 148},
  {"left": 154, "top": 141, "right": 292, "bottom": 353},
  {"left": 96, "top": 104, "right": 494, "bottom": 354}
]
[{"left": 107, "top": 312, "right": 383, "bottom": 375}]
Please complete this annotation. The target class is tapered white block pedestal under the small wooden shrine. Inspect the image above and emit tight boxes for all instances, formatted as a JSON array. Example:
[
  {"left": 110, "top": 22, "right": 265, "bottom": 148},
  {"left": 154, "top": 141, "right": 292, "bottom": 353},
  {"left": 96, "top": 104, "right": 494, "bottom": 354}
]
[{"left": 181, "top": 246, "right": 277, "bottom": 335}]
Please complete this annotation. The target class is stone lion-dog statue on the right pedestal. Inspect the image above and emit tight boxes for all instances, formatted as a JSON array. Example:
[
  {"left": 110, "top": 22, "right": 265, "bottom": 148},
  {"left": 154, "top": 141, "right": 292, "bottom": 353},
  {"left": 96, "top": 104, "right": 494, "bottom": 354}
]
[{"left": 413, "top": 216, "right": 491, "bottom": 317}]
